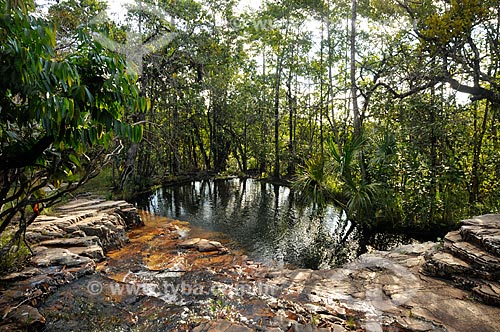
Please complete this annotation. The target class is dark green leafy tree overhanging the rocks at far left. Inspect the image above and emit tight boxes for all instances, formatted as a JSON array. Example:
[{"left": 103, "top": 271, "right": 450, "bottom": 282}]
[{"left": 0, "top": 0, "right": 148, "bottom": 251}]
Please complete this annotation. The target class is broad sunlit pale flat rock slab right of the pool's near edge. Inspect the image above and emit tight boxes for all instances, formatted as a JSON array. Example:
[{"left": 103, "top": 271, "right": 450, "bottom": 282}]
[{"left": 268, "top": 243, "right": 500, "bottom": 332}]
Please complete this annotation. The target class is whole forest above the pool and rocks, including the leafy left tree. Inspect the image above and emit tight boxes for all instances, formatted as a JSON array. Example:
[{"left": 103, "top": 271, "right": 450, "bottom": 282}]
[{"left": 0, "top": 0, "right": 500, "bottom": 254}]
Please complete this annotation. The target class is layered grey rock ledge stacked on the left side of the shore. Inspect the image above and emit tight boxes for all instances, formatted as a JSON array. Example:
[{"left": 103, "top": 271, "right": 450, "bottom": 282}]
[{"left": 0, "top": 199, "right": 144, "bottom": 331}]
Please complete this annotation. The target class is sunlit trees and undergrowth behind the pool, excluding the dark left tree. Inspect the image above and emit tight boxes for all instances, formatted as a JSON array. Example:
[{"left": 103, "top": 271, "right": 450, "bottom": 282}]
[{"left": 106, "top": 0, "right": 500, "bottom": 233}]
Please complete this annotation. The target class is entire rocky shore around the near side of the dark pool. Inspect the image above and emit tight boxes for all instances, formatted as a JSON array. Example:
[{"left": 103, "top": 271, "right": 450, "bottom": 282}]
[{"left": 0, "top": 199, "right": 500, "bottom": 332}]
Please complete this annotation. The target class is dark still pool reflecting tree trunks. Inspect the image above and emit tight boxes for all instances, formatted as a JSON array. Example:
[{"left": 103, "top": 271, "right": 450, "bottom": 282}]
[{"left": 136, "top": 179, "right": 408, "bottom": 269}]
